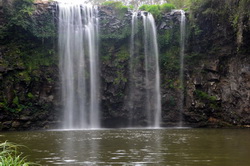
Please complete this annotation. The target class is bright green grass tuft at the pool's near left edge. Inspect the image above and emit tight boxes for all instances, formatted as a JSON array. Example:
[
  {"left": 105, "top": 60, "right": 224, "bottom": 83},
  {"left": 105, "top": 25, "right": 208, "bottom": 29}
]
[{"left": 0, "top": 141, "right": 39, "bottom": 166}]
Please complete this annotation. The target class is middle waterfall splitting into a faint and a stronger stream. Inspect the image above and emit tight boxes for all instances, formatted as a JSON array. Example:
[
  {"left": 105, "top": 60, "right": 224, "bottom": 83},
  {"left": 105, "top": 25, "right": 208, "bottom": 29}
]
[{"left": 129, "top": 12, "right": 161, "bottom": 127}]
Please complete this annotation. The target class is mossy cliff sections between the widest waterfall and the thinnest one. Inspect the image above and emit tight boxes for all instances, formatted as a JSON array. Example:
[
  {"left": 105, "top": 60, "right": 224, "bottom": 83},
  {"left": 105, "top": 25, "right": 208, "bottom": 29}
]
[{"left": 97, "top": 6, "right": 186, "bottom": 127}]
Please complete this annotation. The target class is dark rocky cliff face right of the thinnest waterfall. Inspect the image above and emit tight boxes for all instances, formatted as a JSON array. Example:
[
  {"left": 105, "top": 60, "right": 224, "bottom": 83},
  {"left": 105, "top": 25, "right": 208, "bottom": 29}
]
[{"left": 185, "top": 0, "right": 250, "bottom": 127}]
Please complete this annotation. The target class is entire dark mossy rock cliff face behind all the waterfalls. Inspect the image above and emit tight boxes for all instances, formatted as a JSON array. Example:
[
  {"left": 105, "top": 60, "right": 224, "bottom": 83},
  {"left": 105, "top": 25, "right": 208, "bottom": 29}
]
[{"left": 0, "top": 0, "right": 250, "bottom": 130}]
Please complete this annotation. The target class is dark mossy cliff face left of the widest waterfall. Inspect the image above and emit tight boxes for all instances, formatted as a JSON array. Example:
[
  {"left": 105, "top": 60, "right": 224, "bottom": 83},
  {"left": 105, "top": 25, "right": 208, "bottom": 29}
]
[{"left": 0, "top": 1, "right": 59, "bottom": 130}]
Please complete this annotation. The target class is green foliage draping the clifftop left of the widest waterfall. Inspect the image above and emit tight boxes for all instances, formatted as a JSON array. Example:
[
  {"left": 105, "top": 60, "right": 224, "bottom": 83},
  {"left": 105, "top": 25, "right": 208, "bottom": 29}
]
[{"left": 0, "top": 0, "right": 56, "bottom": 42}]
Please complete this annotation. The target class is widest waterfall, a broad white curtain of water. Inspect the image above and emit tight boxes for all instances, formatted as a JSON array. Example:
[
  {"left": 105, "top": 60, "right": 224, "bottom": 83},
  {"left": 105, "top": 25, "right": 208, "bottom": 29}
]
[{"left": 58, "top": 1, "right": 100, "bottom": 129}]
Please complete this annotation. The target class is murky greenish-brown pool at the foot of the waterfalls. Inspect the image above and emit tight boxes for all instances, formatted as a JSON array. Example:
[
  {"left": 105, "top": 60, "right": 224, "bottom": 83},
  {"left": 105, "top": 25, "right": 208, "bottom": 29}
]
[{"left": 0, "top": 129, "right": 250, "bottom": 166}]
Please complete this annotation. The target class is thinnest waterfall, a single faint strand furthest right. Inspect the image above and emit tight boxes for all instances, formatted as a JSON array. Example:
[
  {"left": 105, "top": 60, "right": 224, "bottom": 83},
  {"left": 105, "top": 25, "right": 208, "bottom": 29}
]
[{"left": 179, "top": 10, "right": 186, "bottom": 127}]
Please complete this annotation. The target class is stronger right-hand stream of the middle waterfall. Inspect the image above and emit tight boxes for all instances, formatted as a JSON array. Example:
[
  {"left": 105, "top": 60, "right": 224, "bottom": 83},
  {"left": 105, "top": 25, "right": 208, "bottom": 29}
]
[{"left": 142, "top": 12, "right": 161, "bottom": 127}]
